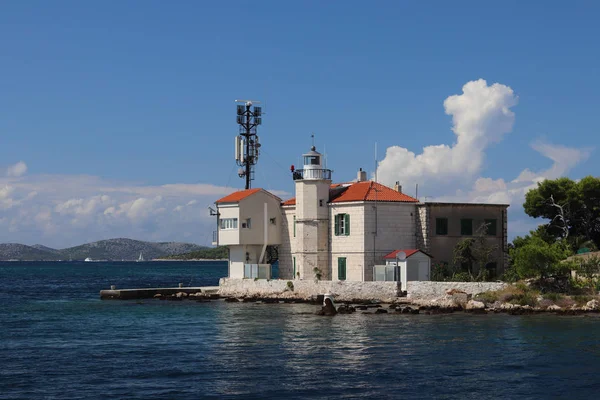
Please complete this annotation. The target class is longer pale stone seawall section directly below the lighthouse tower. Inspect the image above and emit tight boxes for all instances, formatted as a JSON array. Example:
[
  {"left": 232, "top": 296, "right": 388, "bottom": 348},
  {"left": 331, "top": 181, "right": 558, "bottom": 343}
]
[{"left": 219, "top": 278, "right": 399, "bottom": 302}]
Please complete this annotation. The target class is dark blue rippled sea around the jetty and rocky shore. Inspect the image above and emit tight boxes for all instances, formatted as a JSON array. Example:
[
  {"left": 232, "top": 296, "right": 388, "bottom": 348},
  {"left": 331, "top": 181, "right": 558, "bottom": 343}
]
[{"left": 0, "top": 262, "right": 600, "bottom": 399}]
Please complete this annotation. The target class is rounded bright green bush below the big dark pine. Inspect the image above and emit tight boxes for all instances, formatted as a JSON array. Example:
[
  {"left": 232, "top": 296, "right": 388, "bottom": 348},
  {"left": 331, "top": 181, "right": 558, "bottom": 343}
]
[{"left": 510, "top": 235, "right": 571, "bottom": 280}]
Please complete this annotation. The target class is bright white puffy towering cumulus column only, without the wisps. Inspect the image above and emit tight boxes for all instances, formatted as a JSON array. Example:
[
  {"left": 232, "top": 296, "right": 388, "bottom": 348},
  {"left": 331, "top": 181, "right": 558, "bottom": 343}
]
[{"left": 377, "top": 79, "right": 518, "bottom": 191}]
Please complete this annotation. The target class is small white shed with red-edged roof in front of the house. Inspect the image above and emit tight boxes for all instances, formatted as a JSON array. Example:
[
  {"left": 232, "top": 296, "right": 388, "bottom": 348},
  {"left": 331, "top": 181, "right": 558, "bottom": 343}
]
[{"left": 377, "top": 249, "right": 432, "bottom": 290}]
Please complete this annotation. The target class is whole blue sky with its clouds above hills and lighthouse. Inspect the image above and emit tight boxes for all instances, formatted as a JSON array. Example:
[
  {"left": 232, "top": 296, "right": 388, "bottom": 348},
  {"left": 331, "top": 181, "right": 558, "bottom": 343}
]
[{"left": 0, "top": 0, "right": 600, "bottom": 248}]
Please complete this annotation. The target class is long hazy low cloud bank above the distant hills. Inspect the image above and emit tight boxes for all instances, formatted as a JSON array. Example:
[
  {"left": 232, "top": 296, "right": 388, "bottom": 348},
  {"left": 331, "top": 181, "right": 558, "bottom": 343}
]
[{"left": 0, "top": 170, "right": 288, "bottom": 247}]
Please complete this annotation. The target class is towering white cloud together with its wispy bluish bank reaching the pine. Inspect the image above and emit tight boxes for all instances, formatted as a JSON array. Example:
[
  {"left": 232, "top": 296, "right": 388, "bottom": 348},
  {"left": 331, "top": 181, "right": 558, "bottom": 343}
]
[{"left": 377, "top": 79, "right": 593, "bottom": 236}]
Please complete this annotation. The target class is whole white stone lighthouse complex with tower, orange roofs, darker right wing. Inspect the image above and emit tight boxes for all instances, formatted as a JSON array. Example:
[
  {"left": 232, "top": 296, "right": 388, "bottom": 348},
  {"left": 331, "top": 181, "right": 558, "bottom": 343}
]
[{"left": 213, "top": 146, "right": 508, "bottom": 281}]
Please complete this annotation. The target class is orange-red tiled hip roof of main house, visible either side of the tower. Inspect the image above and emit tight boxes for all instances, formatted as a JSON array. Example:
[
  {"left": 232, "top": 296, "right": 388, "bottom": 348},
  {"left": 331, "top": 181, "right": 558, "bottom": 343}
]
[{"left": 281, "top": 181, "right": 419, "bottom": 206}]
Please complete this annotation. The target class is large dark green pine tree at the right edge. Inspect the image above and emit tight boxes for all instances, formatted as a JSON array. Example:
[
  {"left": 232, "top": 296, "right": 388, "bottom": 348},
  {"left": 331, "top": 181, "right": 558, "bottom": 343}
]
[{"left": 523, "top": 176, "right": 600, "bottom": 251}]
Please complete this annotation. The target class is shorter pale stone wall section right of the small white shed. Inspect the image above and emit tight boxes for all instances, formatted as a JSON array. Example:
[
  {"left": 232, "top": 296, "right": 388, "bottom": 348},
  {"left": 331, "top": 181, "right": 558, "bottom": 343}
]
[{"left": 407, "top": 281, "right": 508, "bottom": 300}]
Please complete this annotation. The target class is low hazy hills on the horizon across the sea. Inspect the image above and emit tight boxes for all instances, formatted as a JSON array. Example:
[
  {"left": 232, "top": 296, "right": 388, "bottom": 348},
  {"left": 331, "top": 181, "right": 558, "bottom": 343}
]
[{"left": 0, "top": 238, "right": 208, "bottom": 261}]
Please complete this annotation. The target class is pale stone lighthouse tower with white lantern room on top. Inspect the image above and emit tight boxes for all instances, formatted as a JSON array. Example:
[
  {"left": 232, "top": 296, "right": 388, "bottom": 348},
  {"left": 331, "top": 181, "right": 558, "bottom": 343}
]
[{"left": 294, "top": 146, "right": 331, "bottom": 280}]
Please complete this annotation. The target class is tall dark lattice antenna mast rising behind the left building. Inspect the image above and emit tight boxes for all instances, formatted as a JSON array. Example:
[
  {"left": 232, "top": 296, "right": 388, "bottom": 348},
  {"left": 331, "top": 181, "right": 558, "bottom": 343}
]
[{"left": 235, "top": 100, "right": 262, "bottom": 189}]
